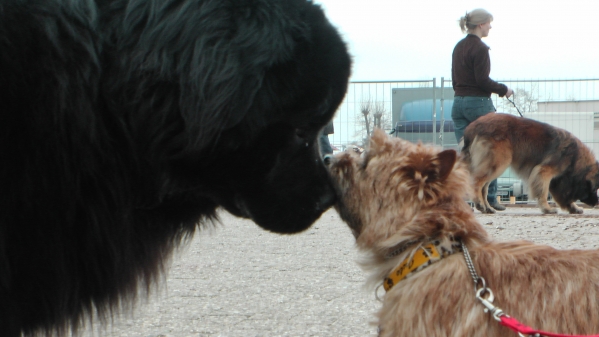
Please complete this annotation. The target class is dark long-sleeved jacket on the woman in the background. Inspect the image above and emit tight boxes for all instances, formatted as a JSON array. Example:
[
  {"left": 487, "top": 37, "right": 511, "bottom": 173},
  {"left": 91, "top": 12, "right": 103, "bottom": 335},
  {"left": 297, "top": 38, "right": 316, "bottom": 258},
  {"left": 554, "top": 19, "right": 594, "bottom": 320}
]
[{"left": 451, "top": 34, "right": 507, "bottom": 97}]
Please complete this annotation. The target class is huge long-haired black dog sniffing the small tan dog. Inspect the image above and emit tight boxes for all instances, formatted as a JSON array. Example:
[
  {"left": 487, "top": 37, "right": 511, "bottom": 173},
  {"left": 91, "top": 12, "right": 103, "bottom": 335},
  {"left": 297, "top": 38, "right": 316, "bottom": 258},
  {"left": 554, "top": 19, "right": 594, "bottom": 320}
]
[{"left": 0, "top": 0, "right": 350, "bottom": 337}]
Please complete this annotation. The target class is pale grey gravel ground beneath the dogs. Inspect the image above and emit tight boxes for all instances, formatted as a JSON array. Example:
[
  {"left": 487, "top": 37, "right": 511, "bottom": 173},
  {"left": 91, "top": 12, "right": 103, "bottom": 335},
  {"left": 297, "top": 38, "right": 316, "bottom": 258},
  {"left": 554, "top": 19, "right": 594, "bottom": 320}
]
[{"left": 81, "top": 207, "right": 599, "bottom": 337}]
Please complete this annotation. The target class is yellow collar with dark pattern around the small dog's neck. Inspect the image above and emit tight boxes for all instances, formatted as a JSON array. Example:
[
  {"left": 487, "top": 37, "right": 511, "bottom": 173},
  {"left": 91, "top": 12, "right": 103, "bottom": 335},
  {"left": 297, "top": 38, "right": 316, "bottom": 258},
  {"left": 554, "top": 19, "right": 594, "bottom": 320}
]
[{"left": 383, "top": 239, "right": 461, "bottom": 291}]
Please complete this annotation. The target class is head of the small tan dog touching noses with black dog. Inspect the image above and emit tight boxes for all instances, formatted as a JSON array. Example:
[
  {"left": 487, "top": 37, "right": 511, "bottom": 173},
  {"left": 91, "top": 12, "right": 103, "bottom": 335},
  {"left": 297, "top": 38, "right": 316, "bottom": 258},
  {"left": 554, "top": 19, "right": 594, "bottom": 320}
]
[{"left": 329, "top": 130, "right": 470, "bottom": 246}]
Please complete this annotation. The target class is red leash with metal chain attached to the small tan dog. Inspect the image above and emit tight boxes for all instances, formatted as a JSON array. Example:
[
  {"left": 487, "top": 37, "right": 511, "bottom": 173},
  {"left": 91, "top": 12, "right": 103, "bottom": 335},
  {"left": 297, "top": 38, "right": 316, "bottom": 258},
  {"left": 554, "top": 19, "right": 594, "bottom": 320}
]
[{"left": 461, "top": 242, "right": 599, "bottom": 337}]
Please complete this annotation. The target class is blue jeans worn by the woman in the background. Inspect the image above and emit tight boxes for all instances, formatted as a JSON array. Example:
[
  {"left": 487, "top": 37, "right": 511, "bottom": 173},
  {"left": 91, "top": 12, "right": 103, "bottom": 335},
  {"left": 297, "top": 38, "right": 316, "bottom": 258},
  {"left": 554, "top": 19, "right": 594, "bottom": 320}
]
[{"left": 451, "top": 96, "right": 497, "bottom": 204}]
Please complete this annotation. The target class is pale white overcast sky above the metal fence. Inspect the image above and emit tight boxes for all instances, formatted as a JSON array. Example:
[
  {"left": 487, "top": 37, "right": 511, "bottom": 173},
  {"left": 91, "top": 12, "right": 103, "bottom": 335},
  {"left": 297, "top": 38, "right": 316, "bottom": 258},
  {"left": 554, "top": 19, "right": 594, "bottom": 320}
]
[{"left": 314, "top": 0, "right": 599, "bottom": 81}]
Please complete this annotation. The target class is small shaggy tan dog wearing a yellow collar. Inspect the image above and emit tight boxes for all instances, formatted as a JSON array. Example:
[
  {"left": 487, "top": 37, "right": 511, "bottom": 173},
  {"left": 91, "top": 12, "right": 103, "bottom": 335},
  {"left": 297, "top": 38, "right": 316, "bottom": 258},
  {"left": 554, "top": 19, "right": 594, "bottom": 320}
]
[{"left": 329, "top": 130, "right": 599, "bottom": 337}]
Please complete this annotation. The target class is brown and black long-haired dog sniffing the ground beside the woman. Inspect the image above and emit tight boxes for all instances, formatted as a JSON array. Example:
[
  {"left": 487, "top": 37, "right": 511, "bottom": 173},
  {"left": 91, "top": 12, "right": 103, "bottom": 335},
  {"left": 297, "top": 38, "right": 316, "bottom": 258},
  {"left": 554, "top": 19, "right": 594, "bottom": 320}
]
[{"left": 463, "top": 113, "right": 599, "bottom": 214}]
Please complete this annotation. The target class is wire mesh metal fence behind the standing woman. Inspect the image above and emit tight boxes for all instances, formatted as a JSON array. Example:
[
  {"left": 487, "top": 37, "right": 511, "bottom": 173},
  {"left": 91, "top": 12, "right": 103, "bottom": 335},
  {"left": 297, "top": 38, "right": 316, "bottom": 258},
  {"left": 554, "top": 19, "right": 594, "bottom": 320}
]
[{"left": 329, "top": 77, "right": 599, "bottom": 201}]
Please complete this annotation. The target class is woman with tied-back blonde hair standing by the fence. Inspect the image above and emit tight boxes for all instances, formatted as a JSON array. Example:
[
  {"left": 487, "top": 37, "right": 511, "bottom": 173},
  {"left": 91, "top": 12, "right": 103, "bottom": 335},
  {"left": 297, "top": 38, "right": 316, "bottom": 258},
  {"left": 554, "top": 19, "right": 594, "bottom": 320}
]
[{"left": 451, "top": 8, "right": 513, "bottom": 211}]
